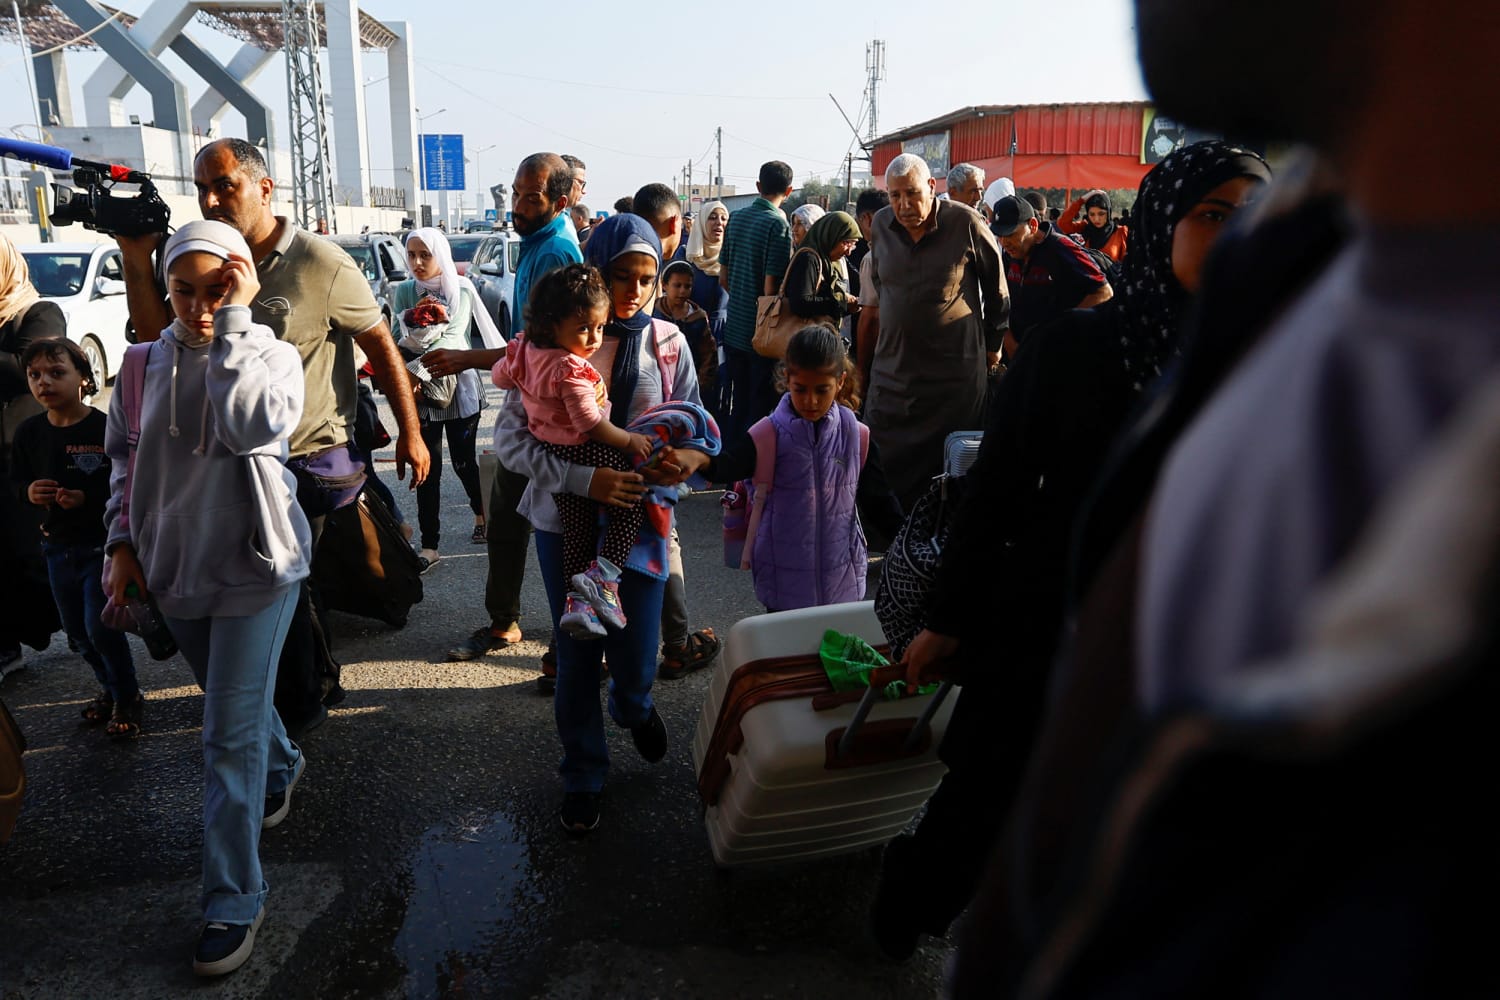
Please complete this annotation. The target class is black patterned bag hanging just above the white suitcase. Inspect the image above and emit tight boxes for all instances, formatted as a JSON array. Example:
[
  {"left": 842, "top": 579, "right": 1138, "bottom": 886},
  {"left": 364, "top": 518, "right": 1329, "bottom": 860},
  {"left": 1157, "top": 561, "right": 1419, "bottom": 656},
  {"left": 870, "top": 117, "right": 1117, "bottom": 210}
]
[{"left": 875, "top": 430, "right": 981, "bottom": 663}]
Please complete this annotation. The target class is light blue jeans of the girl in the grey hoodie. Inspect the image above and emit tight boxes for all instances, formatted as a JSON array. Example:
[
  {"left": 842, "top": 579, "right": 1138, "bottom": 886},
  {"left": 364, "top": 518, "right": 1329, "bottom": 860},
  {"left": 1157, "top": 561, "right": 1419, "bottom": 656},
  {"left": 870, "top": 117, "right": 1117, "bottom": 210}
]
[{"left": 167, "top": 583, "right": 302, "bottom": 924}]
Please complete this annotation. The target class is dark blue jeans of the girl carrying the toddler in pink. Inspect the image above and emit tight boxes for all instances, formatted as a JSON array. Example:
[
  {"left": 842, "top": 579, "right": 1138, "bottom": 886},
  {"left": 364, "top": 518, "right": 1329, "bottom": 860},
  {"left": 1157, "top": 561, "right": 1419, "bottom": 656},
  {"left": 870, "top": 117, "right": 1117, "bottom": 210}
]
[{"left": 536, "top": 531, "right": 666, "bottom": 792}]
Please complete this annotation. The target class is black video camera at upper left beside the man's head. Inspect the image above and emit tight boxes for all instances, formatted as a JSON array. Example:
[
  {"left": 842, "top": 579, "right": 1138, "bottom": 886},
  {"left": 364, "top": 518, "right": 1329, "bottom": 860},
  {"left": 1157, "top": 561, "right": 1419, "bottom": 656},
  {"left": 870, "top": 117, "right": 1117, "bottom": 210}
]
[{"left": 0, "top": 138, "right": 171, "bottom": 237}]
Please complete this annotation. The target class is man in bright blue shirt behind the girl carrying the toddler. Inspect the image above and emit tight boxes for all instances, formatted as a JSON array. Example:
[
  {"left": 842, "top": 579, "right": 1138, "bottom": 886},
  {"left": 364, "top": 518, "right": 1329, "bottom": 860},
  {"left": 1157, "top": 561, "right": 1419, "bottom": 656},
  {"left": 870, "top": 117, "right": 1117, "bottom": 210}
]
[{"left": 423, "top": 153, "right": 584, "bottom": 671}]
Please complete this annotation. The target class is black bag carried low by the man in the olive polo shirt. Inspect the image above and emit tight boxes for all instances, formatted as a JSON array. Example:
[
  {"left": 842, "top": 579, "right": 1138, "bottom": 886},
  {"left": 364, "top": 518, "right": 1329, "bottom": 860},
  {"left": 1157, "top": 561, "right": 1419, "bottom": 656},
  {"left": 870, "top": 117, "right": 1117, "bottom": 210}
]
[{"left": 312, "top": 490, "right": 422, "bottom": 628}]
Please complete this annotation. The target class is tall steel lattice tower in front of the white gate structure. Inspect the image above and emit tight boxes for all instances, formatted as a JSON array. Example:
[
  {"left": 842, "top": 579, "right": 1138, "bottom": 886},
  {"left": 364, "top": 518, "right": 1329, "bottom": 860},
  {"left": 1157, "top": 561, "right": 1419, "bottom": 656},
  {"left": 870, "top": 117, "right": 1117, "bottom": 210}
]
[{"left": 282, "top": 0, "right": 336, "bottom": 229}]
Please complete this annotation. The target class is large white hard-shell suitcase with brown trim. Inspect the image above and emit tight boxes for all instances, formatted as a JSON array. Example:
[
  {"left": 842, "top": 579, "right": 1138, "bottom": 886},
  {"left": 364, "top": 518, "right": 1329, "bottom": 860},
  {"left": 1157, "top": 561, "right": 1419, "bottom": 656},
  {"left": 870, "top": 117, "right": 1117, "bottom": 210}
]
[{"left": 693, "top": 601, "right": 951, "bottom": 867}]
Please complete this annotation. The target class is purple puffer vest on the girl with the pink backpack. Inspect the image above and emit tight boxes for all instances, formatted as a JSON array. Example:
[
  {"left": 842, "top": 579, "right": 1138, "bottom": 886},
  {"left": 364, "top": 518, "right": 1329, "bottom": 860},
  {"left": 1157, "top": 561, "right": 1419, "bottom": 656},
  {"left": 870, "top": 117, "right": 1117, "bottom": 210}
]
[{"left": 752, "top": 396, "right": 869, "bottom": 612}]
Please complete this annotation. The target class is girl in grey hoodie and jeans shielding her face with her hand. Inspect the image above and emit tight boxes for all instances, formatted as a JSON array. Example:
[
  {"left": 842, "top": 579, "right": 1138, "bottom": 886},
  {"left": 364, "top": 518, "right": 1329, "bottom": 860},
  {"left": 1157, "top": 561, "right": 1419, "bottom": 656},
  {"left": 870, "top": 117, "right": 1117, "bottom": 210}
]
[{"left": 105, "top": 222, "right": 312, "bottom": 976}]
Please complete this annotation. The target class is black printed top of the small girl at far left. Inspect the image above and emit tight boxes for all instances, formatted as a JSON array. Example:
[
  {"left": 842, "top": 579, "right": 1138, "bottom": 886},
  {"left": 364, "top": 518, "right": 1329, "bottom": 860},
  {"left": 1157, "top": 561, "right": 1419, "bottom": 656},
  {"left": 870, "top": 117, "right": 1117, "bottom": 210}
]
[{"left": 11, "top": 409, "right": 110, "bottom": 546}]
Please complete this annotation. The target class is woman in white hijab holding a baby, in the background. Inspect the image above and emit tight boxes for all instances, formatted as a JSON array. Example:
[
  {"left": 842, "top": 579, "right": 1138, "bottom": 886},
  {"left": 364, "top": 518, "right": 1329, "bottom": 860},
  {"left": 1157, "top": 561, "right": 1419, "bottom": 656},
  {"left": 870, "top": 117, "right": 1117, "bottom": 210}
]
[{"left": 390, "top": 226, "right": 504, "bottom": 571}]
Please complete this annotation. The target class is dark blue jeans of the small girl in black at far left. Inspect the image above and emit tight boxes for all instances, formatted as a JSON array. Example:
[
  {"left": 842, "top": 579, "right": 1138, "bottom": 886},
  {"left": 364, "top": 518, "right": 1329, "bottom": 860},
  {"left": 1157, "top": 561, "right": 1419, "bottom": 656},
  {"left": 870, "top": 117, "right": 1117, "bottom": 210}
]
[{"left": 42, "top": 541, "right": 141, "bottom": 705}]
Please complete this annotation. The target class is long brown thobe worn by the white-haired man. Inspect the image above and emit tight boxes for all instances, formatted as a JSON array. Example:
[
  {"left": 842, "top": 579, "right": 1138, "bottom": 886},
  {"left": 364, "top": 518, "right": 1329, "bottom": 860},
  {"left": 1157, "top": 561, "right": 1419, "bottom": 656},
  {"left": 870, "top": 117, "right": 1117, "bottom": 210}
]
[{"left": 864, "top": 201, "right": 1010, "bottom": 510}]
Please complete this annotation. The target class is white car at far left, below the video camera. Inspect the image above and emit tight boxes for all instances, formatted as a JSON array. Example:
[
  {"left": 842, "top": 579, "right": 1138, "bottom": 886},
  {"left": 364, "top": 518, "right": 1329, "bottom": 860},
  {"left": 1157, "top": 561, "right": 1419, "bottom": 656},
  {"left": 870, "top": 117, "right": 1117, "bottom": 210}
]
[{"left": 20, "top": 243, "right": 131, "bottom": 387}]
